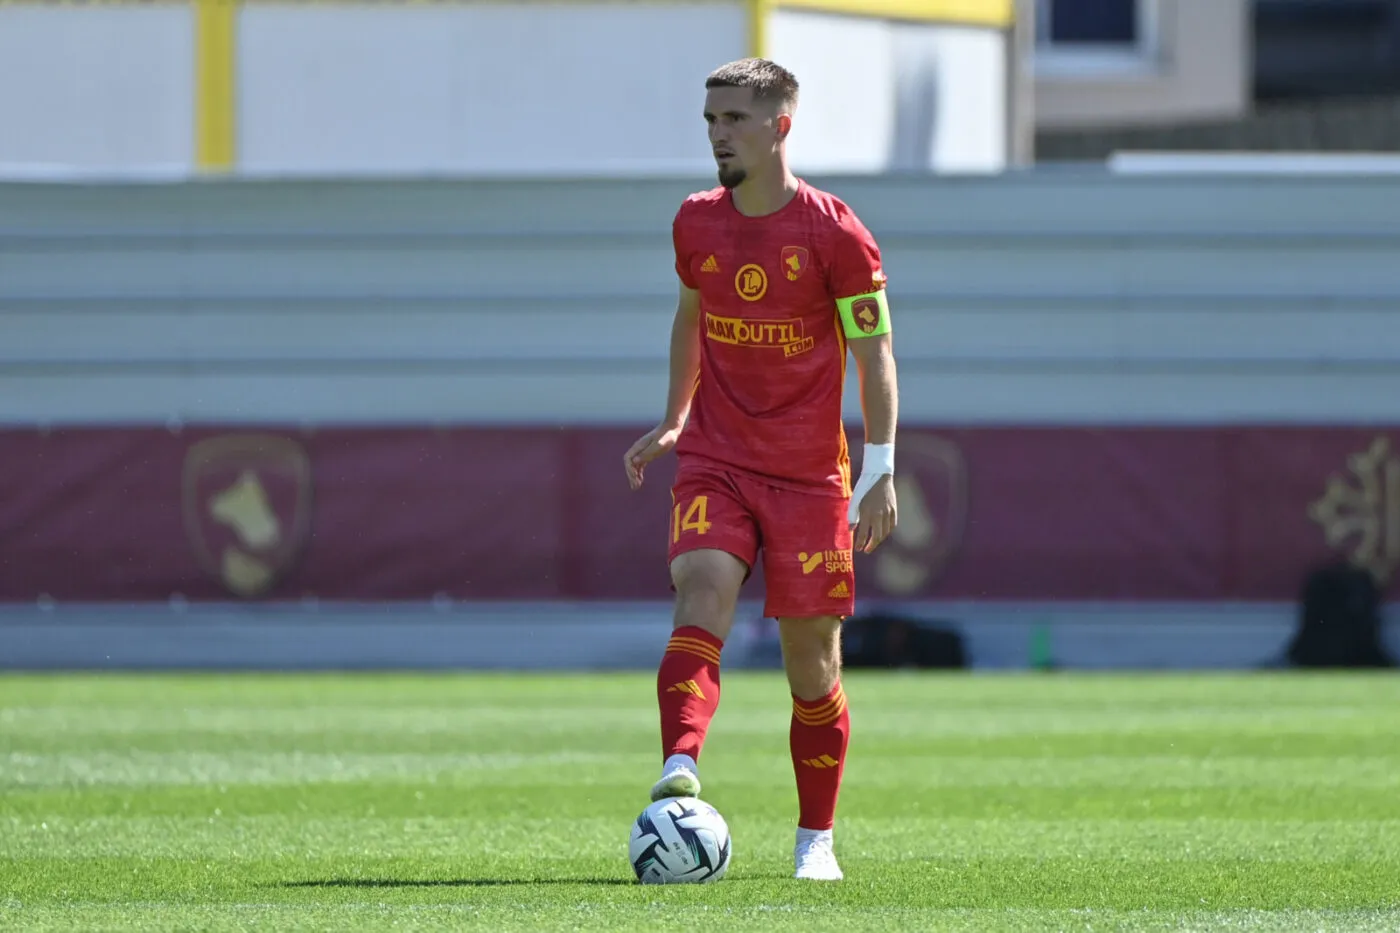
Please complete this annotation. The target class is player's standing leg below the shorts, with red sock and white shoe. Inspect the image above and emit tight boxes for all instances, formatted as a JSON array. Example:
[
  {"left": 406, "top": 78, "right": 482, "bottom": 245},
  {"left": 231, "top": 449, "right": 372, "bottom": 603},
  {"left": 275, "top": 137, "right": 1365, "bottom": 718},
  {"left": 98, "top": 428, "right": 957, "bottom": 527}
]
[{"left": 778, "top": 616, "right": 851, "bottom": 881}]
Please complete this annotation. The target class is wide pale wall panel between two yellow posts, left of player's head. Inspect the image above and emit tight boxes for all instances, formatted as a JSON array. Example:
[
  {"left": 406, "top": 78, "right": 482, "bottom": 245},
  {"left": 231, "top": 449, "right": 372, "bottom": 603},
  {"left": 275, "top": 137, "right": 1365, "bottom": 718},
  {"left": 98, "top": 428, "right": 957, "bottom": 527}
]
[{"left": 238, "top": 0, "right": 748, "bottom": 174}]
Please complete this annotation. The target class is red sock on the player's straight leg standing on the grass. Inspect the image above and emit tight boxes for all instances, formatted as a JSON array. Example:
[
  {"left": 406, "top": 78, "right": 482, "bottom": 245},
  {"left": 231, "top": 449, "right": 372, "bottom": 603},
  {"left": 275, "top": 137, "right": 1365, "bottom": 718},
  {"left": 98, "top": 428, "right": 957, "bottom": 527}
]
[{"left": 788, "top": 681, "right": 851, "bottom": 829}]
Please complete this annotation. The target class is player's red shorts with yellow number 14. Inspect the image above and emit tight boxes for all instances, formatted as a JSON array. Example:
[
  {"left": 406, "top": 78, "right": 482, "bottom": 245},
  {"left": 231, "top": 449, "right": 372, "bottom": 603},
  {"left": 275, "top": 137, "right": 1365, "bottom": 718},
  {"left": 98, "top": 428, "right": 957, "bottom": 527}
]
[{"left": 666, "top": 461, "right": 855, "bottom": 618}]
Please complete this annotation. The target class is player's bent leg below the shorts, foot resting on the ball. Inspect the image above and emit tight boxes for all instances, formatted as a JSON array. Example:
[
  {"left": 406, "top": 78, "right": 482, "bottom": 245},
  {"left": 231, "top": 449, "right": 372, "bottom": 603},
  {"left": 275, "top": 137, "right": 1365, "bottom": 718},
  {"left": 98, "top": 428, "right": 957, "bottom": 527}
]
[{"left": 651, "top": 548, "right": 748, "bottom": 800}]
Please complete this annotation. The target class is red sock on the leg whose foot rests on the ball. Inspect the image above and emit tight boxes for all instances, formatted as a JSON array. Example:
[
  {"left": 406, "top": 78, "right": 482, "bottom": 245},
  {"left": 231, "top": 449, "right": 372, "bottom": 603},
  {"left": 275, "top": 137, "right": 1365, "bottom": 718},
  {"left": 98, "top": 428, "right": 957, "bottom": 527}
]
[{"left": 657, "top": 626, "right": 724, "bottom": 761}]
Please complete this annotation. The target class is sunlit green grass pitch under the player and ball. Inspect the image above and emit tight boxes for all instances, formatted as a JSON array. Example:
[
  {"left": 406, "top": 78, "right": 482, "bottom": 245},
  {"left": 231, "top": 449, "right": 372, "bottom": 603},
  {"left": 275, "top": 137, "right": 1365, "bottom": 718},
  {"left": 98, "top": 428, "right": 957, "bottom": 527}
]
[{"left": 0, "top": 671, "right": 1400, "bottom": 933}]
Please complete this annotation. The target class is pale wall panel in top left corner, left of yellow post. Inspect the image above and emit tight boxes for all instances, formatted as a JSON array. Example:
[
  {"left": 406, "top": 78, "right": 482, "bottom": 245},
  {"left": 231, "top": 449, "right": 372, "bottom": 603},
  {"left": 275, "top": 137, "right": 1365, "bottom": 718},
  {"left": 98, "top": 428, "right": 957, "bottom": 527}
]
[{"left": 0, "top": 4, "right": 195, "bottom": 171}]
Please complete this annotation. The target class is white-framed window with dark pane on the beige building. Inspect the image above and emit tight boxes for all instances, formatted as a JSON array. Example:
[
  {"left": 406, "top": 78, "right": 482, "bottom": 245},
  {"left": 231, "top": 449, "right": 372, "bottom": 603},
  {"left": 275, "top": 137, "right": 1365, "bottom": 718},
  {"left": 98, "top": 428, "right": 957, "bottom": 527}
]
[{"left": 1036, "top": 0, "right": 1156, "bottom": 74}]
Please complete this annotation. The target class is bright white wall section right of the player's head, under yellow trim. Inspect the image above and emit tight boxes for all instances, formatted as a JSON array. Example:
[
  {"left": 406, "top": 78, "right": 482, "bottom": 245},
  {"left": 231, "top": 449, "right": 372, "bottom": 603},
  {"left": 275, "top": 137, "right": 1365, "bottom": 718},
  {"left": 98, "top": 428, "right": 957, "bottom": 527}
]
[{"left": 770, "top": 10, "right": 1009, "bottom": 172}]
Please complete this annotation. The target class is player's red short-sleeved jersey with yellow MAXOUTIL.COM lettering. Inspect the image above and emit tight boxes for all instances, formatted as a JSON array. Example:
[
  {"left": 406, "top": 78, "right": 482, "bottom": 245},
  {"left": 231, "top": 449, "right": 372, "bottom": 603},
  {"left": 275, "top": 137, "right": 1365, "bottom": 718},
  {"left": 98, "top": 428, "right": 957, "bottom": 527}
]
[{"left": 672, "top": 181, "right": 885, "bottom": 496}]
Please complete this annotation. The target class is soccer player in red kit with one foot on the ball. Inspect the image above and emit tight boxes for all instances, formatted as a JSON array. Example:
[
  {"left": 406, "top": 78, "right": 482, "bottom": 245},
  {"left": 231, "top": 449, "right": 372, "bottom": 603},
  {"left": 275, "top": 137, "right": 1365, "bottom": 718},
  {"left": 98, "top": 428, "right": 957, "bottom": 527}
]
[{"left": 624, "top": 59, "right": 897, "bottom": 881}]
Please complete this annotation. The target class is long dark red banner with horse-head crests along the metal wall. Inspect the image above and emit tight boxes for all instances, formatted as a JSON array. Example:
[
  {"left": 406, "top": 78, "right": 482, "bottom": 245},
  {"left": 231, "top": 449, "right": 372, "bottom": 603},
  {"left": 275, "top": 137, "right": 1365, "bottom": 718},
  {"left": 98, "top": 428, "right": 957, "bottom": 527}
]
[{"left": 0, "top": 426, "right": 1400, "bottom": 602}]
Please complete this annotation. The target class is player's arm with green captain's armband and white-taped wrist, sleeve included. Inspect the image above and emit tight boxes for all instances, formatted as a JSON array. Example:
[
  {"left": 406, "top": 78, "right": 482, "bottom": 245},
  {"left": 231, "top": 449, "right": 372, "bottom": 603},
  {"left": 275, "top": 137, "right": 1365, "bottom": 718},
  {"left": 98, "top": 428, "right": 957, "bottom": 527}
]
[{"left": 832, "top": 214, "right": 899, "bottom": 553}]
